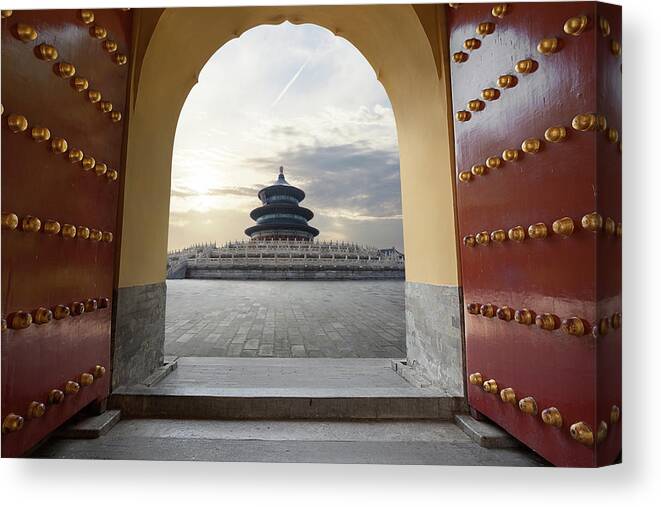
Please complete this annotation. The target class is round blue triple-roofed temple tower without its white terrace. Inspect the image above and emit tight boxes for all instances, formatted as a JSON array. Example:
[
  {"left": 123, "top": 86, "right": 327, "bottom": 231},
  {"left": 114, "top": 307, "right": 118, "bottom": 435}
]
[{"left": 246, "top": 166, "right": 319, "bottom": 241}]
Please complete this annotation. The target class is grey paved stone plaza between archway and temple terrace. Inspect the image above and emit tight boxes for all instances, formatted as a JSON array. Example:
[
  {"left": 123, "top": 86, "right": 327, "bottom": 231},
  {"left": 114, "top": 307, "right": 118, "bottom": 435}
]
[{"left": 165, "top": 280, "right": 406, "bottom": 358}]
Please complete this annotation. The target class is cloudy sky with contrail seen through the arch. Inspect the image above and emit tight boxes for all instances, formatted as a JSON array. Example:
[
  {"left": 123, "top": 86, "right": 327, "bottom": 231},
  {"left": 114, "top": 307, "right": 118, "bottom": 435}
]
[{"left": 168, "top": 22, "right": 404, "bottom": 252}]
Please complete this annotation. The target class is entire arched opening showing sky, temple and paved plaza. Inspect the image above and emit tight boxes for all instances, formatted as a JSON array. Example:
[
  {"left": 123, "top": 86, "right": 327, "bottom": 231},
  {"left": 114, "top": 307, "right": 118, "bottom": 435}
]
[{"left": 165, "top": 22, "right": 406, "bottom": 365}]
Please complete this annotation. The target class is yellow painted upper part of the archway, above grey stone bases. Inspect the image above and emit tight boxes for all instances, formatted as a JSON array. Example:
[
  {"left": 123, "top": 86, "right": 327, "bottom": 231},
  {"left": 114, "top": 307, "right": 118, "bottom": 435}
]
[{"left": 118, "top": 5, "right": 457, "bottom": 287}]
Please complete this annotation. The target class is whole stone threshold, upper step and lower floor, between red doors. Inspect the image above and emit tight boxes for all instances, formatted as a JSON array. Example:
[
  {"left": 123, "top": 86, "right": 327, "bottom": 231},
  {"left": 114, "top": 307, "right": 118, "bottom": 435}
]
[{"left": 32, "top": 357, "right": 546, "bottom": 466}]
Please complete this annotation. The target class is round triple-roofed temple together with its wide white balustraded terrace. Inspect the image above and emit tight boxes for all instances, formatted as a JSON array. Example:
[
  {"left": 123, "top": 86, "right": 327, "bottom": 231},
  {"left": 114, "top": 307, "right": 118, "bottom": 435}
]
[{"left": 167, "top": 166, "right": 404, "bottom": 280}]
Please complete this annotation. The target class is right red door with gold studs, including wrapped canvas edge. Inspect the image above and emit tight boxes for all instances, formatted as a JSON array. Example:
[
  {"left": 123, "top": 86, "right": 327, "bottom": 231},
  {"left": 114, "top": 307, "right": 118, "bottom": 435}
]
[{"left": 448, "top": 2, "right": 622, "bottom": 467}]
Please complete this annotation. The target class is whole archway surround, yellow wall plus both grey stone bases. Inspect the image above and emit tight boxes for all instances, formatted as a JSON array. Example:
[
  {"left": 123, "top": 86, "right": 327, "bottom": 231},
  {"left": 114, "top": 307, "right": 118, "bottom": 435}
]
[{"left": 113, "top": 5, "right": 464, "bottom": 396}]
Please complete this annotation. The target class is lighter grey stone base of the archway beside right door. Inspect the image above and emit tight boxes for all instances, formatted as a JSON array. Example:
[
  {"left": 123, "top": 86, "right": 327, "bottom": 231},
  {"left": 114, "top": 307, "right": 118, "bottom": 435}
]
[{"left": 406, "top": 282, "right": 464, "bottom": 396}]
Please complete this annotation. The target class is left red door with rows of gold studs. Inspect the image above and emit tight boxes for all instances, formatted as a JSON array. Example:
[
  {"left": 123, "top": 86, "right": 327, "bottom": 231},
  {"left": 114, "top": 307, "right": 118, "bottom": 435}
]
[{"left": 2, "top": 9, "right": 131, "bottom": 456}]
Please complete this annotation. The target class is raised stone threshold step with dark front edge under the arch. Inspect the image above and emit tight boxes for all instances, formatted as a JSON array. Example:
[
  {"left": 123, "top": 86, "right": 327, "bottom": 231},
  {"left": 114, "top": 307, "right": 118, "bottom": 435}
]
[{"left": 110, "top": 357, "right": 466, "bottom": 421}]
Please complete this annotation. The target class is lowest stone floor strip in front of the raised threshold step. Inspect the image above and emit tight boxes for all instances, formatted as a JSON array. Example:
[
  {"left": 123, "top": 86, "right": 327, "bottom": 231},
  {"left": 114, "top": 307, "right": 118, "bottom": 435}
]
[{"left": 32, "top": 419, "right": 545, "bottom": 466}]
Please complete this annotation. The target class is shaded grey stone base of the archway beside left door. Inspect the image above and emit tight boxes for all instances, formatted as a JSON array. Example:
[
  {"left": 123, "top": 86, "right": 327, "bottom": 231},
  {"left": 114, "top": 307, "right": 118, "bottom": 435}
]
[{"left": 112, "top": 282, "right": 167, "bottom": 389}]
